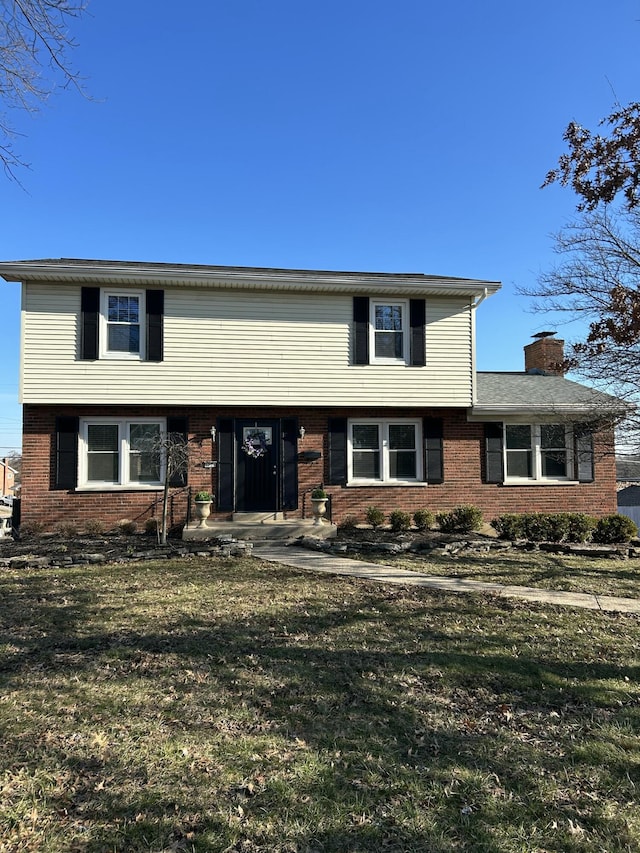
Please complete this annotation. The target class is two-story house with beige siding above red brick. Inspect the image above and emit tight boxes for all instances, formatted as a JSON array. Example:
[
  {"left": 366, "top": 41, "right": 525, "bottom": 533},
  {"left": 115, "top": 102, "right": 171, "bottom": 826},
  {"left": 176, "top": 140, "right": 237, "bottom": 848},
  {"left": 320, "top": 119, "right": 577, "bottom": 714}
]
[{"left": 0, "top": 259, "right": 616, "bottom": 528}]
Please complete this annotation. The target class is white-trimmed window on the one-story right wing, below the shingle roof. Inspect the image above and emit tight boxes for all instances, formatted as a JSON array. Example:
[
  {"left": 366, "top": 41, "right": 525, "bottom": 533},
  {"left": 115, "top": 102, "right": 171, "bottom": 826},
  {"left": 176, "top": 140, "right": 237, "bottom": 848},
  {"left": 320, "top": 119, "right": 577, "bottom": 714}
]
[{"left": 504, "top": 424, "right": 573, "bottom": 481}]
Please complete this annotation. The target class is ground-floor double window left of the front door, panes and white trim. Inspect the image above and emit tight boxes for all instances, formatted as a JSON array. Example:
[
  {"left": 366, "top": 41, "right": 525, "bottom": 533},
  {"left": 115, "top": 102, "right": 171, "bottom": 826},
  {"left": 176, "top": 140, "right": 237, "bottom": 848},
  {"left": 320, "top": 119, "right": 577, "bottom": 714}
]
[{"left": 78, "top": 418, "right": 166, "bottom": 489}]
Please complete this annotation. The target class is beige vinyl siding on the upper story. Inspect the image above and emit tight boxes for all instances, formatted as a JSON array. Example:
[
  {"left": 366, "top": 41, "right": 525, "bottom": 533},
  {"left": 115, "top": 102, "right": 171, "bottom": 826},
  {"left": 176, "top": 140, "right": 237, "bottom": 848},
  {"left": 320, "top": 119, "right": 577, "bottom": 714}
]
[{"left": 23, "top": 284, "right": 471, "bottom": 407}]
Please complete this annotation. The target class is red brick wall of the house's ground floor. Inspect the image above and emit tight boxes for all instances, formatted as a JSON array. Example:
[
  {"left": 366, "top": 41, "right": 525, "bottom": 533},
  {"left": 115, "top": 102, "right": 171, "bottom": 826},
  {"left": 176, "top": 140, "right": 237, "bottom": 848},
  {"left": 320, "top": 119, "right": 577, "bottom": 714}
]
[{"left": 22, "top": 405, "right": 617, "bottom": 530}]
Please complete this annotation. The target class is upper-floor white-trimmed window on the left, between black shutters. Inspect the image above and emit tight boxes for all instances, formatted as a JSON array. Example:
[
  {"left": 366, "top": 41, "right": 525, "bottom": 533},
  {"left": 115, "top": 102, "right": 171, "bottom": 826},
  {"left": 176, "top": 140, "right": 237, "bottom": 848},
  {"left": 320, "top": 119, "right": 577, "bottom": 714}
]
[{"left": 100, "top": 290, "right": 145, "bottom": 359}]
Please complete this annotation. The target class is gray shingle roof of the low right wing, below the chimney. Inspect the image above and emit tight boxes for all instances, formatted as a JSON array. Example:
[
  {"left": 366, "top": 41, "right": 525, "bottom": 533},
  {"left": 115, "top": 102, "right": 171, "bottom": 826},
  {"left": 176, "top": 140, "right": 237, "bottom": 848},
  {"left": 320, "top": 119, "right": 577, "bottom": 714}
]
[{"left": 473, "top": 372, "right": 625, "bottom": 415}]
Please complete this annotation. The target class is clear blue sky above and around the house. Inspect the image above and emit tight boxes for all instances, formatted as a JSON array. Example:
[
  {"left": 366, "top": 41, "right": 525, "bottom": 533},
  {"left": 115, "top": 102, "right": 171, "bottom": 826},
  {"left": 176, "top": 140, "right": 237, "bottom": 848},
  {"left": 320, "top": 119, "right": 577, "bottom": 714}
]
[{"left": 0, "top": 0, "right": 640, "bottom": 455}]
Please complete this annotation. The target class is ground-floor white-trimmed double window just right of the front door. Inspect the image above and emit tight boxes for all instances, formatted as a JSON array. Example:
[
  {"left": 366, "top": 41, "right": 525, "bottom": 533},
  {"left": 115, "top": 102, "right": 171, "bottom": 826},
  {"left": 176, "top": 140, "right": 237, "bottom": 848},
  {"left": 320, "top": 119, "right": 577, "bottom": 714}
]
[{"left": 348, "top": 418, "right": 422, "bottom": 483}]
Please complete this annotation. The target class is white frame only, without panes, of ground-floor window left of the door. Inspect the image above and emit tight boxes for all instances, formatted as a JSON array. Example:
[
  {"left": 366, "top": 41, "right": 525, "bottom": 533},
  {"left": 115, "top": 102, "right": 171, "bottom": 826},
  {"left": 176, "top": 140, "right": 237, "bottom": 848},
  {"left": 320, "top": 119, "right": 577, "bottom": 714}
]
[{"left": 78, "top": 417, "right": 167, "bottom": 491}]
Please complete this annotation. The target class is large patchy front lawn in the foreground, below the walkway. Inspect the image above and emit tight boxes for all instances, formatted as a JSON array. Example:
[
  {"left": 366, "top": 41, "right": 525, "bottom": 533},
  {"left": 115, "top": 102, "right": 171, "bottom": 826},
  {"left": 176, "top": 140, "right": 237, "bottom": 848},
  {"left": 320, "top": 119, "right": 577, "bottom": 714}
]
[{"left": 0, "top": 558, "right": 640, "bottom": 853}]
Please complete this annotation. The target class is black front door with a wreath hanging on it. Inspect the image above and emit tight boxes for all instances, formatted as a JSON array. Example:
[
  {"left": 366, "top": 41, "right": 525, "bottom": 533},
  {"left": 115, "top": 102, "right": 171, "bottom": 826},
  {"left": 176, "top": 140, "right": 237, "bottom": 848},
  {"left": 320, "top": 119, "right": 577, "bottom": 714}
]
[{"left": 236, "top": 419, "right": 280, "bottom": 512}]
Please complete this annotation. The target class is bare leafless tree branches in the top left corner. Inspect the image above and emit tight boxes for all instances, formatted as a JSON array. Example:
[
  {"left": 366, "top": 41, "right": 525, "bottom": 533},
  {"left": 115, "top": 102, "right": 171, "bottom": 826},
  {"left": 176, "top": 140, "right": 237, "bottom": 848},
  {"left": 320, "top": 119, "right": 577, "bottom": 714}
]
[{"left": 0, "top": 0, "right": 87, "bottom": 179}]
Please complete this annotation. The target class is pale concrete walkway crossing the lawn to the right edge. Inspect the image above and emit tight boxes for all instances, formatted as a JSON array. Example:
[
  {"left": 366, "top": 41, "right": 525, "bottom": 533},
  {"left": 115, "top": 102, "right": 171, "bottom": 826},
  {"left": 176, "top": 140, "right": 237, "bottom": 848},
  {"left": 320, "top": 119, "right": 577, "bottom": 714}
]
[{"left": 254, "top": 545, "right": 640, "bottom": 613}]
